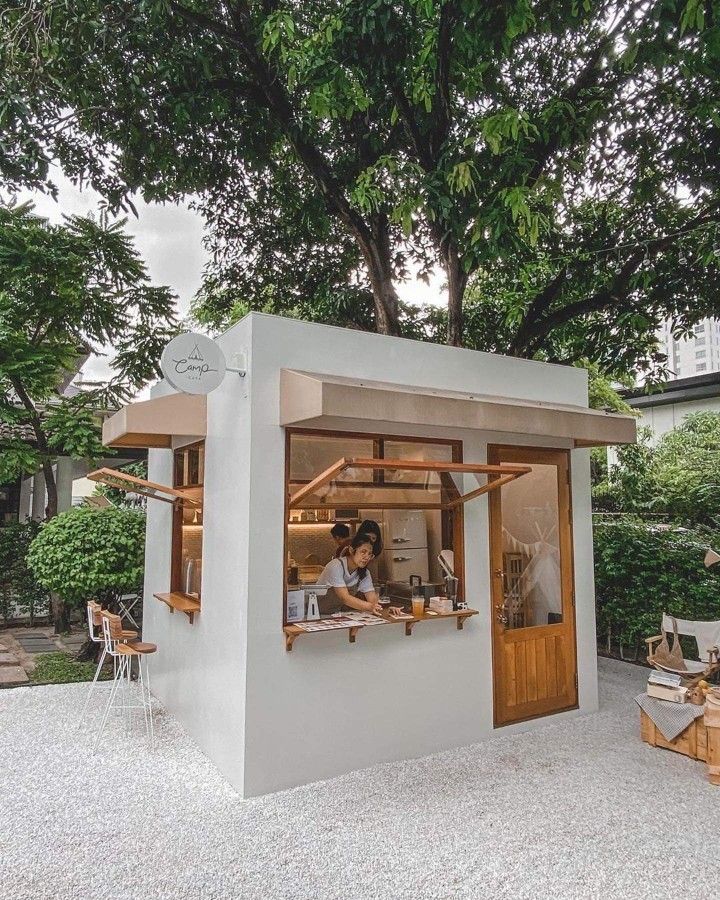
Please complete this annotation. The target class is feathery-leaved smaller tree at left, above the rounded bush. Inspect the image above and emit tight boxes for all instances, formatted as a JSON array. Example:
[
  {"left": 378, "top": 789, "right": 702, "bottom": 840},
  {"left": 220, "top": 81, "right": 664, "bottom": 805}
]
[{"left": 0, "top": 205, "right": 175, "bottom": 517}]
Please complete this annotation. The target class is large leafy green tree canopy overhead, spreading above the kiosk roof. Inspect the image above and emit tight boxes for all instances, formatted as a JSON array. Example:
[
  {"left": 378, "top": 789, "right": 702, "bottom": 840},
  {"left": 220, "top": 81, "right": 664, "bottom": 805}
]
[{"left": 0, "top": 0, "right": 720, "bottom": 374}]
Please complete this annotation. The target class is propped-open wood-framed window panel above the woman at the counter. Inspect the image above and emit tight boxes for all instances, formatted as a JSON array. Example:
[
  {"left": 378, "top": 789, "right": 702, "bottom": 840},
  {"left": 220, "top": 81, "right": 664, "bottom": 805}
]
[{"left": 289, "top": 457, "right": 531, "bottom": 510}]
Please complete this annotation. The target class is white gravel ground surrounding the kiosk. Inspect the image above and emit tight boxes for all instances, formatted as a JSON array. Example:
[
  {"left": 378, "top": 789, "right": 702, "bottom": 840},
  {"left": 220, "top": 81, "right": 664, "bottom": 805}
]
[{"left": 0, "top": 660, "right": 720, "bottom": 900}]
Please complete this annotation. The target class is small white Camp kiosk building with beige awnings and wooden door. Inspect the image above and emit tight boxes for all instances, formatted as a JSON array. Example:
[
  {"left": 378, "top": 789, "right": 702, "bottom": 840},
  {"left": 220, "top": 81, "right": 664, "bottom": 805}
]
[{"left": 93, "top": 313, "right": 635, "bottom": 797}]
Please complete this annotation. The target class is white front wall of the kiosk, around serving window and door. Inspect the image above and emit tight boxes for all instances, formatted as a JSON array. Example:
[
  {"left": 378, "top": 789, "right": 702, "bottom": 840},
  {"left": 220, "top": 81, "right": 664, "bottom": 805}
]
[{"left": 246, "top": 315, "right": 597, "bottom": 795}]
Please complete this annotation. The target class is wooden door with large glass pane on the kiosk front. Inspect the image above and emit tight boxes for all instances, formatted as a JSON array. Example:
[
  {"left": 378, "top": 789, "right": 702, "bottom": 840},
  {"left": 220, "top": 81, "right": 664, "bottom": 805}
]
[{"left": 488, "top": 447, "right": 577, "bottom": 726}]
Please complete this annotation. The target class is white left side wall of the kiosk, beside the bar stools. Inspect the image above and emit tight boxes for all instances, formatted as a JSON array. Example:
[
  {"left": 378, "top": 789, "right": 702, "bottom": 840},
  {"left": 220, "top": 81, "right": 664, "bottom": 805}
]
[{"left": 143, "top": 320, "right": 250, "bottom": 792}]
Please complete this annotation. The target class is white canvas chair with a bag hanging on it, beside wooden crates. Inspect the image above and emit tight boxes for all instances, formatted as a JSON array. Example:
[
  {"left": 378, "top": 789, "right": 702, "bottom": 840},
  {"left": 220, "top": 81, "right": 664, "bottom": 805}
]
[{"left": 645, "top": 613, "right": 720, "bottom": 687}]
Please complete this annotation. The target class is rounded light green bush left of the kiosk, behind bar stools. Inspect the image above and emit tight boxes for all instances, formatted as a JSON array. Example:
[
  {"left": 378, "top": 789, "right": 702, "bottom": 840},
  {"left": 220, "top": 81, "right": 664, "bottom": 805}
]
[{"left": 28, "top": 507, "right": 145, "bottom": 606}]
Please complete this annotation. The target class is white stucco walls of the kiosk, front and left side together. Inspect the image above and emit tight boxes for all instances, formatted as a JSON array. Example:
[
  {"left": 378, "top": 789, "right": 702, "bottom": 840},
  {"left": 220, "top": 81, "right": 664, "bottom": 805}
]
[{"left": 144, "top": 314, "right": 597, "bottom": 796}]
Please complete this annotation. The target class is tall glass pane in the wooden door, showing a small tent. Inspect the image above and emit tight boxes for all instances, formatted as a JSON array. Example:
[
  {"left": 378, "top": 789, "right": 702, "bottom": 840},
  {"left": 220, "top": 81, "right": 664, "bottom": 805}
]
[{"left": 501, "top": 465, "right": 562, "bottom": 628}]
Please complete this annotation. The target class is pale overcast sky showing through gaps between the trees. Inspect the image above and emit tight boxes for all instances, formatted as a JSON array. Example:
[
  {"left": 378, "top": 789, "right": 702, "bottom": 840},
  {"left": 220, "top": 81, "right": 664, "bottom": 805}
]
[{"left": 20, "top": 176, "right": 447, "bottom": 380}]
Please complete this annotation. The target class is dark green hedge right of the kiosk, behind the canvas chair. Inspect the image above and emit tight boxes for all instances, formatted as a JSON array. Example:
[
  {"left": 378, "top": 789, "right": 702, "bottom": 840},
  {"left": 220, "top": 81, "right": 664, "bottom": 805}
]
[{"left": 594, "top": 519, "right": 720, "bottom": 652}]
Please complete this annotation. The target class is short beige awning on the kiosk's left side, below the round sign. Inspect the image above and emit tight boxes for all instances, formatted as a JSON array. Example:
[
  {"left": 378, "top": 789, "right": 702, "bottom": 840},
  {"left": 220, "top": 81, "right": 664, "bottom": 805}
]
[{"left": 103, "top": 394, "right": 207, "bottom": 447}]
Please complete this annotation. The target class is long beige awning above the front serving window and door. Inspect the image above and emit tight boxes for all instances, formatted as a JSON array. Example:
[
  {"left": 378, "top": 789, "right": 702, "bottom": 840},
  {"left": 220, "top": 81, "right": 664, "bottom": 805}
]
[{"left": 280, "top": 369, "right": 637, "bottom": 447}]
